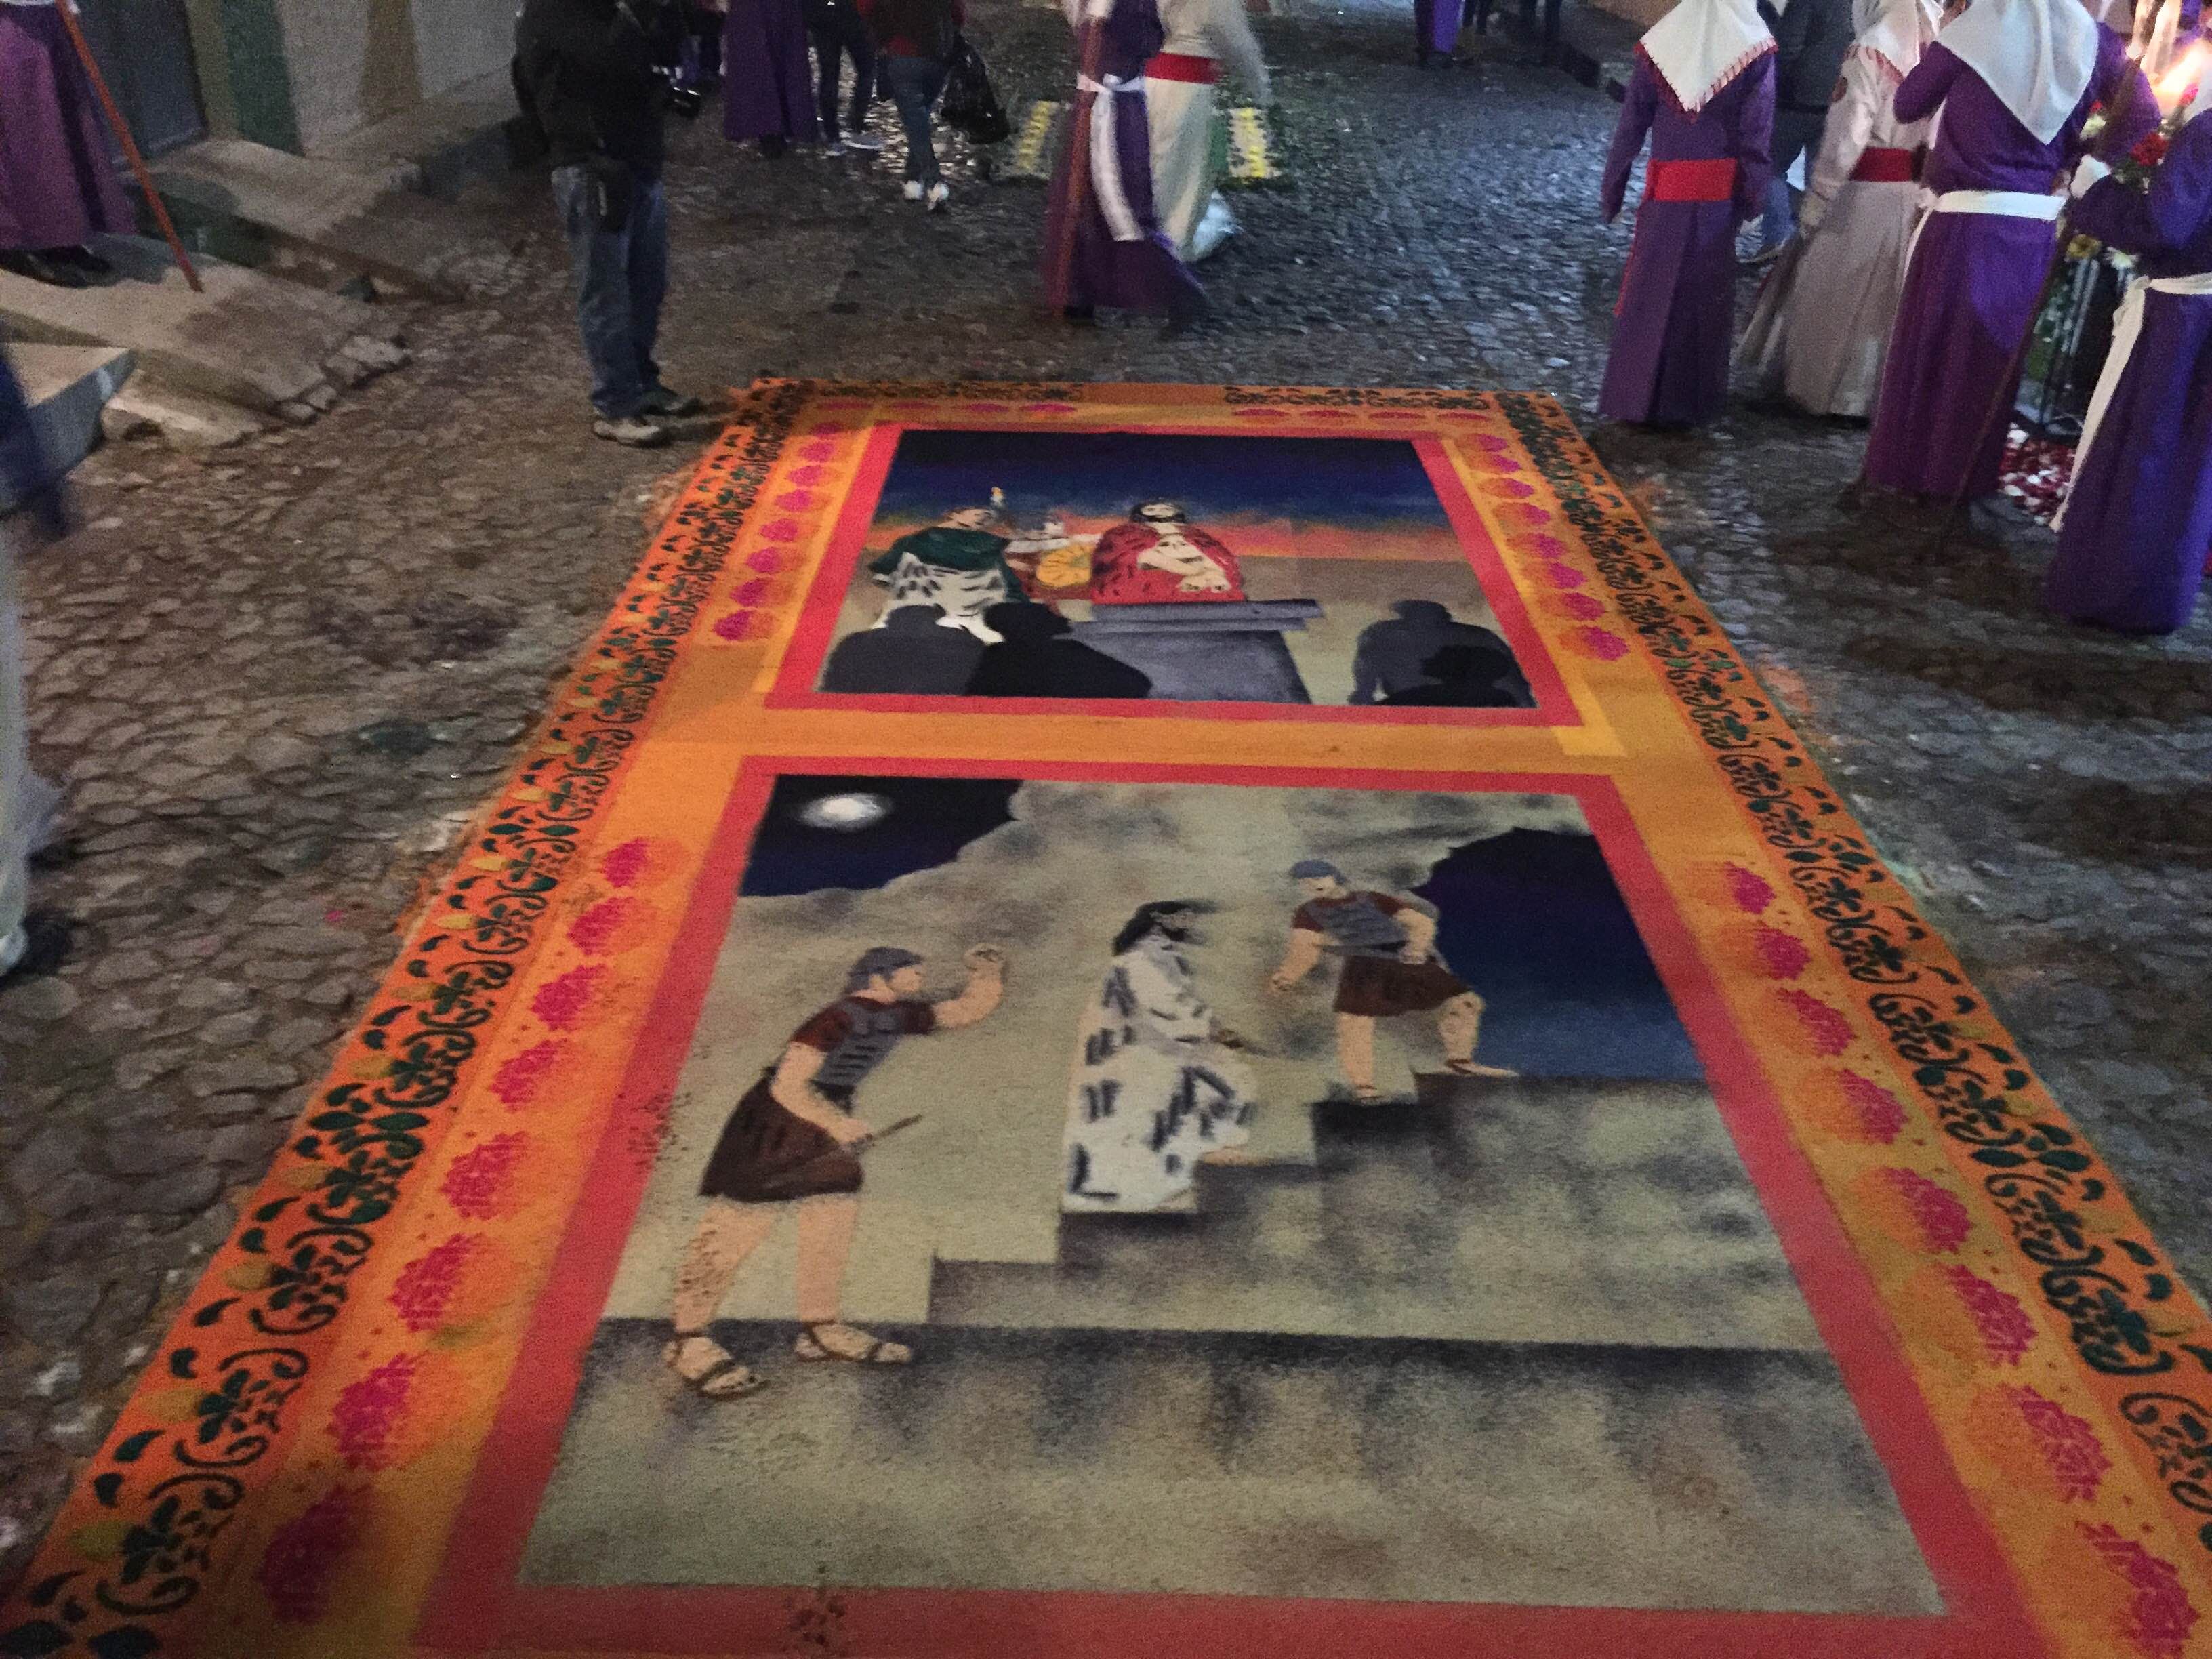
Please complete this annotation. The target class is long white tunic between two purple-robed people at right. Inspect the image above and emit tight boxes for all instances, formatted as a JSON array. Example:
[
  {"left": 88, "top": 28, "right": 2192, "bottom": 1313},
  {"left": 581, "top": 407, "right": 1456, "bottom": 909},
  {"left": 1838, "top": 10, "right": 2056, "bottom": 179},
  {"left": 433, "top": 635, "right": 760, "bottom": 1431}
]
[{"left": 1741, "top": 47, "right": 1929, "bottom": 418}]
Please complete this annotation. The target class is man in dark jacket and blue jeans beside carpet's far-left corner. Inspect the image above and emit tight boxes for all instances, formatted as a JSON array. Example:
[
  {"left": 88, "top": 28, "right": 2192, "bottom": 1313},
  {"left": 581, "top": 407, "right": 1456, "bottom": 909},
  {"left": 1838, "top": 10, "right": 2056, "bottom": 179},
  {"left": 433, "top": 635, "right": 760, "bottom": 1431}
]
[{"left": 516, "top": 0, "right": 701, "bottom": 449}]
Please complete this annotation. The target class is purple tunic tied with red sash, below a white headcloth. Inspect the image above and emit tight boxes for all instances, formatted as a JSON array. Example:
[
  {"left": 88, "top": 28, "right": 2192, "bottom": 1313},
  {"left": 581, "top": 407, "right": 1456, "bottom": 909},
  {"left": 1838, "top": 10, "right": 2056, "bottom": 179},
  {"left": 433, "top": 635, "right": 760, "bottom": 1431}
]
[{"left": 1597, "top": 51, "right": 1774, "bottom": 425}]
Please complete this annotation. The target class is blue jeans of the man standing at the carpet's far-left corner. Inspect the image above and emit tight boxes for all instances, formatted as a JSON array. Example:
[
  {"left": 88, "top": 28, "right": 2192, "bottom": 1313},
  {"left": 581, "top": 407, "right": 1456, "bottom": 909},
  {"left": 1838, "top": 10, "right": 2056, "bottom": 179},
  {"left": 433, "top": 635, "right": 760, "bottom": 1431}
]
[{"left": 553, "top": 166, "right": 668, "bottom": 420}]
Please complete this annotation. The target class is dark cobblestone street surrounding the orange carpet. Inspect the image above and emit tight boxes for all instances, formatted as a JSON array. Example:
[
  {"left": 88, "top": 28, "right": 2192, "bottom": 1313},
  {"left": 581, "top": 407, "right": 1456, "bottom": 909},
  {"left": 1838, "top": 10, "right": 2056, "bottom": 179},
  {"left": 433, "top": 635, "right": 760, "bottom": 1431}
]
[{"left": 0, "top": 0, "right": 2212, "bottom": 1584}]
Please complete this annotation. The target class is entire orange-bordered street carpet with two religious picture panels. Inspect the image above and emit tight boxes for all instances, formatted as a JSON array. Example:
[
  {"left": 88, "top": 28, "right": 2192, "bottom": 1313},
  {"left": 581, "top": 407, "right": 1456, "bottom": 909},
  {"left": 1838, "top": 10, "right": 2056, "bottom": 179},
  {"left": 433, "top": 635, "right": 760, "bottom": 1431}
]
[{"left": 0, "top": 383, "right": 2212, "bottom": 1659}]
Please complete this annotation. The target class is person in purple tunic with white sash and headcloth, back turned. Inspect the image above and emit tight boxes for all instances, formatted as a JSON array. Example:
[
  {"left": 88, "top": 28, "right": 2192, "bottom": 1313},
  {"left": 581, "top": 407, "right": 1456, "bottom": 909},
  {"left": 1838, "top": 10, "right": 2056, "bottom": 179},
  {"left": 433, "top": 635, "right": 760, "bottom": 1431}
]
[{"left": 1865, "top": 0, "right": 2159, "bottom": 510}]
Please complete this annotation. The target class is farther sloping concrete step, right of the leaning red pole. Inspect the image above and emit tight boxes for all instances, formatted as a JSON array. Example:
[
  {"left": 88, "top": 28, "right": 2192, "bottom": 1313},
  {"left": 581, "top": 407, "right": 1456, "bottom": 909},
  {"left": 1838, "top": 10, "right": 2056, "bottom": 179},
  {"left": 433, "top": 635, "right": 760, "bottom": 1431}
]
[{"left": 155, "top": 140, "right": 520, "bottom": 299}]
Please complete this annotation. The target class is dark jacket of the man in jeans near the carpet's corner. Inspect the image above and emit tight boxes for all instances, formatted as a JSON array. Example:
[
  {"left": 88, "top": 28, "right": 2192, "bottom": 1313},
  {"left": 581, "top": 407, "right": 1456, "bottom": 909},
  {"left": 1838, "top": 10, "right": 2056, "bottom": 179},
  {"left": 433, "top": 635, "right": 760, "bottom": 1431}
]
[{"left": 516, "top": 0, "right": 684, "bottom": 177}]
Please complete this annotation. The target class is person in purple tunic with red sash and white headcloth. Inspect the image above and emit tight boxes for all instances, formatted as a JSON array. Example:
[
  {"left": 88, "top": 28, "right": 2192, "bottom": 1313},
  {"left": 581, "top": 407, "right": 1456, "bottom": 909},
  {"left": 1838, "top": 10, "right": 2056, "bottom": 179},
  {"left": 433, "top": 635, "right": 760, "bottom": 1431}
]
[{"left": 1597, "top": 0, "right": 1774, "bottom": 427}]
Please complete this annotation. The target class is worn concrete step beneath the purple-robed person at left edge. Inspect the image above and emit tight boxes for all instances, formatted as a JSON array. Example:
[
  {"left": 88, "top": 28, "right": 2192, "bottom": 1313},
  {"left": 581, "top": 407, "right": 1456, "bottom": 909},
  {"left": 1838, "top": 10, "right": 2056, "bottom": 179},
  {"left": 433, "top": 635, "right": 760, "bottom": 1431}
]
[{"left": 0, "top": 237, "right": 407, "bottom": 425}]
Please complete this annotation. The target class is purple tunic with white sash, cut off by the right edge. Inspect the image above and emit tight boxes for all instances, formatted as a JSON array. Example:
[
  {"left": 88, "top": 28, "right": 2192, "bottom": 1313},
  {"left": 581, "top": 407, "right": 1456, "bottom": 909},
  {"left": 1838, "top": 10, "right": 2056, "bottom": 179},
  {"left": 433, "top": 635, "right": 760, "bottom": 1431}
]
[{"left": 2044, "top": 117, "right": 2212, "bottom": 633}]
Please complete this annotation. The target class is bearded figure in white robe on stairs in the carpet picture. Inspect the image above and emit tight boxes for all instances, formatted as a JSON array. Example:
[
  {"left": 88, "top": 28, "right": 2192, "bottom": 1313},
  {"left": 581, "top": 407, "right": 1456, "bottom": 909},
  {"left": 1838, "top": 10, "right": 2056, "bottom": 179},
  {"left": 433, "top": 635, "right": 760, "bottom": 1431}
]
[{"left": 1062, "top": 907, "right": 1254, "bottom": 1212}]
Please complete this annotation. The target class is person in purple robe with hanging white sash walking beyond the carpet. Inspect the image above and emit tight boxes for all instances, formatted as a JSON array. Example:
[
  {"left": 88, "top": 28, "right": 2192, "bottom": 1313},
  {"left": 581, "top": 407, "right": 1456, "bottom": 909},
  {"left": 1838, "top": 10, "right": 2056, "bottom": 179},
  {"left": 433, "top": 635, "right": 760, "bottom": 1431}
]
[{"left": 1044, "top": 0, "right": 1208, "bottom": 332}]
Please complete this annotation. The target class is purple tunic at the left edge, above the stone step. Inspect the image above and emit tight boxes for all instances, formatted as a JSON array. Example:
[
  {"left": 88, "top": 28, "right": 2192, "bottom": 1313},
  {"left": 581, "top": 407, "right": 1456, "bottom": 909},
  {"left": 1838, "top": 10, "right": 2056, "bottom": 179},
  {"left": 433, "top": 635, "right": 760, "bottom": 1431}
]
[{"left": 0, "top": 5, "right": 133, "bottom": 252}]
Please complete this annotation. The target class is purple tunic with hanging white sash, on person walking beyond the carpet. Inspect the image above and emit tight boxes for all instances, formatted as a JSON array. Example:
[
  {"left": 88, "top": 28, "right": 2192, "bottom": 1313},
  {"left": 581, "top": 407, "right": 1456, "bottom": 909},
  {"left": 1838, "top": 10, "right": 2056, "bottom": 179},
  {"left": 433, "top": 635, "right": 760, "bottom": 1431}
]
[{"left": 1044, "top": 0, "right": 1206, "bottom": 314}]
